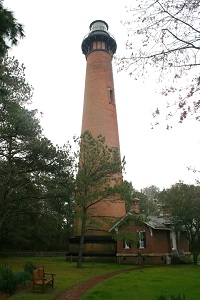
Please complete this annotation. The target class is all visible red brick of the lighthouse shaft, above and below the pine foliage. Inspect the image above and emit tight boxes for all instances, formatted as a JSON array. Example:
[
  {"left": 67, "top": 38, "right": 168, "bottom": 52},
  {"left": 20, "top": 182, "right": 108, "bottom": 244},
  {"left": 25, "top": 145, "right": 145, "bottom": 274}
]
[{"left": 75, "top": 51, "right": 126, "bottom": 235}]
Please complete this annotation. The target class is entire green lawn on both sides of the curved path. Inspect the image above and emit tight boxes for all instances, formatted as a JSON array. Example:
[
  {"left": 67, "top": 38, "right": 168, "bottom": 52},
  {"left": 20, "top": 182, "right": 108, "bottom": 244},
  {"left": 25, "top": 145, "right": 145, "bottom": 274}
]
[{"left": 0, "top": 257, "right": 200, "bottom": 300}]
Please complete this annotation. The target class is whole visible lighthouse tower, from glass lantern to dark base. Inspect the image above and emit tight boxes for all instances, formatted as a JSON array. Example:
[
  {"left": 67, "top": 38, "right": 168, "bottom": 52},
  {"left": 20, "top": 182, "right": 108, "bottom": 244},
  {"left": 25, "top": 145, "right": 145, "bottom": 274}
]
[{"left": 70, "top": 20, "right": 126, "bottom": 256}]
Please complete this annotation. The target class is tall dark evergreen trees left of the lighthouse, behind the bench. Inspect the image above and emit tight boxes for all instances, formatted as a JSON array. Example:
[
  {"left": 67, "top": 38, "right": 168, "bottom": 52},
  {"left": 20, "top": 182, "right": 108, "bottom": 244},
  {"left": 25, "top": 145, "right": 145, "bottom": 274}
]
[{"left": 0, "top": 57, "right": 73, "bottom": 249}]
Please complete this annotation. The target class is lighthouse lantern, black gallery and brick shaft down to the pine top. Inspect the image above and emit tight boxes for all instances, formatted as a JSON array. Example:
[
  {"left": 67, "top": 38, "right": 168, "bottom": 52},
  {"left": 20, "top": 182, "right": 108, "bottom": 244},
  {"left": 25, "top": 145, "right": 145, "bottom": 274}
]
[{"left": 82, "top": 20, "right": 119, "bottom": 148}]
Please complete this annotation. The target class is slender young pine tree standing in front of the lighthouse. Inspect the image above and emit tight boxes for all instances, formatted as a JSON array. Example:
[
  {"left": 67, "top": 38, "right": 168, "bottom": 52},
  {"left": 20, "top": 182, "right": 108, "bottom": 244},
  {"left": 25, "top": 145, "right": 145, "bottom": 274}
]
[{"left": 75, "top": 131, "right": 125, "bottom": 268}]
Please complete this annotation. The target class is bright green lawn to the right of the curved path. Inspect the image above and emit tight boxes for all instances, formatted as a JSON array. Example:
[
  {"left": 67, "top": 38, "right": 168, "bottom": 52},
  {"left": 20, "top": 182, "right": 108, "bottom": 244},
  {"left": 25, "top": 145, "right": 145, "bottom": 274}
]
[{"left": 81, "top": 265, "right": 200, "bottom": 300}]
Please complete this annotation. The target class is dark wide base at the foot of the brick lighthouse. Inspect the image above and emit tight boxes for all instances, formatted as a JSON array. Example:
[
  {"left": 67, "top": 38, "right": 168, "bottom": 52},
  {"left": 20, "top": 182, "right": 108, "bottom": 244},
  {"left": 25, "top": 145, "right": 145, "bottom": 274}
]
[{"left": 66, "top": 236, "right": 117, "bottom": 262}]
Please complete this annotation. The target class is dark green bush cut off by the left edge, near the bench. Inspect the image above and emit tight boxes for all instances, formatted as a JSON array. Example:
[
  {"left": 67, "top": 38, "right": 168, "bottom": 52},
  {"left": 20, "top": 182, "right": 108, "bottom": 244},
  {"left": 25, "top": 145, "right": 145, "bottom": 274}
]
[{"left": 0, "top": 265, "right": 17, "bottom": 294}]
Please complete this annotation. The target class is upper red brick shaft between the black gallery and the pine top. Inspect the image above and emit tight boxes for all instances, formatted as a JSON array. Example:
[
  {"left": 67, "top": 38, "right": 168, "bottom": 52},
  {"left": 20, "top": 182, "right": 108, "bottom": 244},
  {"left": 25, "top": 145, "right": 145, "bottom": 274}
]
[{"left": 82, "top": 51, "right": 120, "bottom": 148}]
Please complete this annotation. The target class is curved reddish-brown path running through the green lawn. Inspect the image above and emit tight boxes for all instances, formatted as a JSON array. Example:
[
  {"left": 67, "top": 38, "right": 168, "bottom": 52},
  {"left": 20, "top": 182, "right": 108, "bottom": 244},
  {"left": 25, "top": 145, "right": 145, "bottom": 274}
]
[{"left": 56, "top": 266, "right": 142, "bottom": 300}]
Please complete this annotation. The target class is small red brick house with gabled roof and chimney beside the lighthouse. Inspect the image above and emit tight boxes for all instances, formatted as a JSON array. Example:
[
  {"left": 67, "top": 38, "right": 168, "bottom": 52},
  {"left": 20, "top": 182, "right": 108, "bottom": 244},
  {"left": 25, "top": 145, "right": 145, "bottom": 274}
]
[{"left": 110, "top": 199, "right": 190, "bottom": 264}]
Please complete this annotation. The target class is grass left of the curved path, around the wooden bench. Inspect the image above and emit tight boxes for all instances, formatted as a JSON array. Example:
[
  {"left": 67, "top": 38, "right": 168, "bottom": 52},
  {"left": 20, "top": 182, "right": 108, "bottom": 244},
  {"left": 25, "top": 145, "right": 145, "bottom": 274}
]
[{"left": 0, "top": 257, "right": 136, "bottom": 300}]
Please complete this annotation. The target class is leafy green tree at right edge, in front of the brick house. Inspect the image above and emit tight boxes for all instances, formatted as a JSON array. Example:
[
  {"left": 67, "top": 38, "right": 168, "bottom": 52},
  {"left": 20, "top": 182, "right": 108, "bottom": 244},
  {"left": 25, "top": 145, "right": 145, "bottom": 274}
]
[{"left": 159, "top": 182, "right": 200, "bottom": 264}]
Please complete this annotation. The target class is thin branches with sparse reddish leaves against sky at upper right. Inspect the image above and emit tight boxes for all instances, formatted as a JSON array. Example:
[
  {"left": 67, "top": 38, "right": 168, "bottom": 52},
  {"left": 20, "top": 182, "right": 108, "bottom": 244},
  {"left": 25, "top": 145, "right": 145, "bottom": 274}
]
[{"left": 119, "top": 0, "right": 200, "bottom": 128}]
